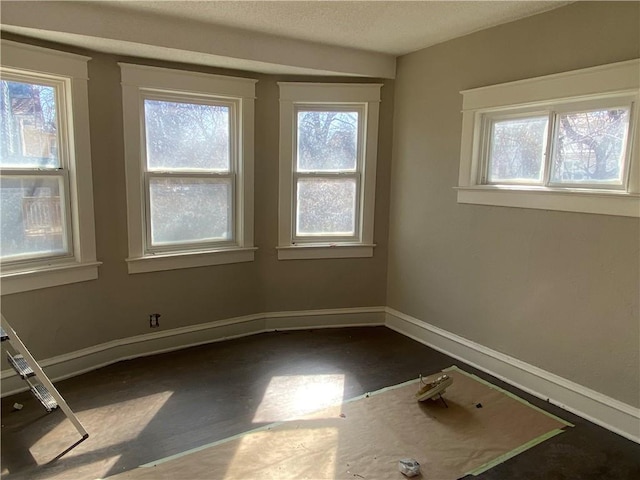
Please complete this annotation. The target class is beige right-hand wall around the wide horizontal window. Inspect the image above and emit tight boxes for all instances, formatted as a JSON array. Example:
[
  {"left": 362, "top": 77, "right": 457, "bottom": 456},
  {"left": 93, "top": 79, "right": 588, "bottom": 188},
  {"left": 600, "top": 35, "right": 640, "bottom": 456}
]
[{"left": 387, "top": 2, "right": 640, "bottom": 407}]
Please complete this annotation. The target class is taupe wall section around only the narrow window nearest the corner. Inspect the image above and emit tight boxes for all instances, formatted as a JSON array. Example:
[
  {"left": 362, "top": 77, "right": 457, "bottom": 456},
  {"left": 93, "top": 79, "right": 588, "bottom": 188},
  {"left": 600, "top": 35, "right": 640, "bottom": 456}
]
[{"left": 255, "top": 77, "right": 393, "bottom": 311}]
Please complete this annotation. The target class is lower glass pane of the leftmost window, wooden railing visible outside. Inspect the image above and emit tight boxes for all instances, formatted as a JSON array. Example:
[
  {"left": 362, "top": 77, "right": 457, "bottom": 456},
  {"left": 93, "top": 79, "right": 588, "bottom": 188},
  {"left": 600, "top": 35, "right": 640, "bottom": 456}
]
[{"left": 0, "top": 176, "right": 68, "bottom": 260}]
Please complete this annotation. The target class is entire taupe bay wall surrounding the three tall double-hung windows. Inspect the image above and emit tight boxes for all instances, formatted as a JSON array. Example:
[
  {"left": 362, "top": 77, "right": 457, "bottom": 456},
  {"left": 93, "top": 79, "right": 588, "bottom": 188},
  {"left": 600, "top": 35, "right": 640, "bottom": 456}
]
[{"left": 2, "top": 35, "right": 393, "bottom": 359}]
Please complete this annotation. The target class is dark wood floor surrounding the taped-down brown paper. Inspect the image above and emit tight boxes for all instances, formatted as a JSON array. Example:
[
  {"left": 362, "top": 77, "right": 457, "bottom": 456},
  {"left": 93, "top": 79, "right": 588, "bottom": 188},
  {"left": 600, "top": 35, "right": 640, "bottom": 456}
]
[{"left": 1, "top": 327, "right": 640, "bottom": 480}]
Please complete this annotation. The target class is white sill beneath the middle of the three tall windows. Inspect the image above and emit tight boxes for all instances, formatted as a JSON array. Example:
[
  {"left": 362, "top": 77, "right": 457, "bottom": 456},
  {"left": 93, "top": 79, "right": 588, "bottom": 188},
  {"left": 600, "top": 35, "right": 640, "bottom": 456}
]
[{"left": 127, "top": 247, "right": 257, "bottom": 274}]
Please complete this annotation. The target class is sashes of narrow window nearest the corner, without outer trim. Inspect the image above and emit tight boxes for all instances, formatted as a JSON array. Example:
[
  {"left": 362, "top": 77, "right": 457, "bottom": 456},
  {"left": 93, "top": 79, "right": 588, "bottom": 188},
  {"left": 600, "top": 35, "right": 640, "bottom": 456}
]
[{"left": 293, "top": 105, "right": 364, "bottom": 239}]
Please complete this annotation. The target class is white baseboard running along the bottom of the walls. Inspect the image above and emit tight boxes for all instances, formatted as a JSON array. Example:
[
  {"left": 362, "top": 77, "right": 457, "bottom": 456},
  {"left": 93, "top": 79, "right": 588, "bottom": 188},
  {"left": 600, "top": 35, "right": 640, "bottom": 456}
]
[{"left": 0, "top": 307, "right": 640, "bottom": 443}]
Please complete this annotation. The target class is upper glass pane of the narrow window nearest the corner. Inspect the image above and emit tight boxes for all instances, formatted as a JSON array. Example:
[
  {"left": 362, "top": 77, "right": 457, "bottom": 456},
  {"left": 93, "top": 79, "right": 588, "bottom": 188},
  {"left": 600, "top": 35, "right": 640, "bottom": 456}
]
[{"left": 297, "top": 111, "right": 358, "bottom": 171}]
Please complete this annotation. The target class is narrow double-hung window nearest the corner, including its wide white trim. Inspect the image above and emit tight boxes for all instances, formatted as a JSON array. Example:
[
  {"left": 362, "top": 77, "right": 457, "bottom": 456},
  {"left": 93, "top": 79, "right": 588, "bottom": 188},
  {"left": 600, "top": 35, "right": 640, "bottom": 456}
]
[{"left": 278, "top": 82, "right": 381, "bottom": 260}]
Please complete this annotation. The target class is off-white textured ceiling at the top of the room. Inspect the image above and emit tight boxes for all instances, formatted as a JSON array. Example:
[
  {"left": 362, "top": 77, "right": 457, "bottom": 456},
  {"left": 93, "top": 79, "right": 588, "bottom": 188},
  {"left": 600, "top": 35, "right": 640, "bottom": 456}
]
[{"left": 99, "top": 0, "right": 571, "bottom": 55}]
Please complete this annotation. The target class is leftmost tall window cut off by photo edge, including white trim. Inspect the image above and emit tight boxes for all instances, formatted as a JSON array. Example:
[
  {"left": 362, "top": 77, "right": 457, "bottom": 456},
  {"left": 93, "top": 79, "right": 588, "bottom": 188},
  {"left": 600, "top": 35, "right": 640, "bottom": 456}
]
[{"left": 0, "top": 40, "right": 100, "bottom": 294}]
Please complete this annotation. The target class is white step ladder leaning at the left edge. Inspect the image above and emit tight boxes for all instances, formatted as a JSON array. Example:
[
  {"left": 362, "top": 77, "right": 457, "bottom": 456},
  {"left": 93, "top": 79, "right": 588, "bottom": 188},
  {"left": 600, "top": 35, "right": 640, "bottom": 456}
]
[{"left": 0, "top": 314, "right": 89, "bottom": 446}]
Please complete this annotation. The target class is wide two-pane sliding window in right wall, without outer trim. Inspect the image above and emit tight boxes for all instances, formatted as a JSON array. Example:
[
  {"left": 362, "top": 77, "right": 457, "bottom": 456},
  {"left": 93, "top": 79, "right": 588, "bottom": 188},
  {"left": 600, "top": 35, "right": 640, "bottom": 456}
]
[{"left": 480, "top": 98, "right": 634, "bottom": 190}]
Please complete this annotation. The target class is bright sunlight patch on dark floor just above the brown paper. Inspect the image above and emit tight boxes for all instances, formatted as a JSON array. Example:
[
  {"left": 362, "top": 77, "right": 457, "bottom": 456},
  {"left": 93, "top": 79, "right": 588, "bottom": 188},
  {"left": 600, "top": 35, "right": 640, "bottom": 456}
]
[{"left": 253, "top": 374, "right": 345, "bottom": 423}]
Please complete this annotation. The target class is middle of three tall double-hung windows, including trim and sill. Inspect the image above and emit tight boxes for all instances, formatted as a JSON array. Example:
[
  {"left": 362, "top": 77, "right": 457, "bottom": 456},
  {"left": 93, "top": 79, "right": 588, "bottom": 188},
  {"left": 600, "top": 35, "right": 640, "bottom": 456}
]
[{"left": 120, "top": 64, "right": 256, "bottom": 273}]
